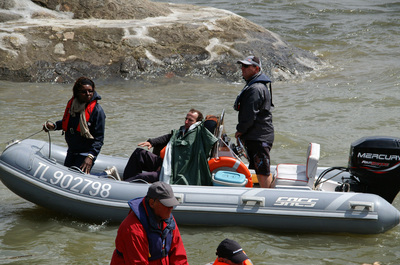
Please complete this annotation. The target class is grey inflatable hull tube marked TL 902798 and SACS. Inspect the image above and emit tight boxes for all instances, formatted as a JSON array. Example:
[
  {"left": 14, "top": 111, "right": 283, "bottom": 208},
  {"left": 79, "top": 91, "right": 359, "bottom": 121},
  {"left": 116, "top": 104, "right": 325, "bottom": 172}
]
[{"left": 0, "top": 140, "right": 400, "bottom": 234}]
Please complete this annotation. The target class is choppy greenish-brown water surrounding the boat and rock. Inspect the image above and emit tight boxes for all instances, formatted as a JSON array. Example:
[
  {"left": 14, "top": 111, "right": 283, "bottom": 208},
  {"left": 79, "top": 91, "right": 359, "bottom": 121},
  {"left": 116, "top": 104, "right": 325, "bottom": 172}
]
[{"left": 0, "top": 0, "right": 400, "bottom": 264}]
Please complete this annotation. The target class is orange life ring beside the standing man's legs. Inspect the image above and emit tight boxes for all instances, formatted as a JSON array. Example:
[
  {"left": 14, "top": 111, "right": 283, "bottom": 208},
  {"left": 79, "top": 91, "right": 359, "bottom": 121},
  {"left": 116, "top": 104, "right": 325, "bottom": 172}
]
[{"left": 208, "top": 156, "right": 253, "bottom": 188}]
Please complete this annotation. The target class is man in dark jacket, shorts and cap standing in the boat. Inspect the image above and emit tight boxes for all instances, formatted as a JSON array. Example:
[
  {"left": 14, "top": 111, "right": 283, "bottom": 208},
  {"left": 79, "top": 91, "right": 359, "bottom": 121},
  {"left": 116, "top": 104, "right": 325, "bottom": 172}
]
[{"left": 233, "top": 56, "right": 274, "bottom": 188}]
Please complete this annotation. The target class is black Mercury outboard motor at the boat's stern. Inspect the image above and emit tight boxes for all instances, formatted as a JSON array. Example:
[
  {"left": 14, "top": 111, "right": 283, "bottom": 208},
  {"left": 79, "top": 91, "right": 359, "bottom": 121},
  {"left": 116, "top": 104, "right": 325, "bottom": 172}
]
[{"left": 348, "top": 136, "right": 400, "bottom": 203}]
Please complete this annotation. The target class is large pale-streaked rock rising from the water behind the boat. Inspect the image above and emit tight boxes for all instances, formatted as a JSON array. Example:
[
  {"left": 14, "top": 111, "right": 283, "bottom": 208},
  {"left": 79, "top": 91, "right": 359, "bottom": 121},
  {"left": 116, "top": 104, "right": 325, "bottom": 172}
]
[{"left": 0, "top": 0, "right": 323, "bottom": 82}]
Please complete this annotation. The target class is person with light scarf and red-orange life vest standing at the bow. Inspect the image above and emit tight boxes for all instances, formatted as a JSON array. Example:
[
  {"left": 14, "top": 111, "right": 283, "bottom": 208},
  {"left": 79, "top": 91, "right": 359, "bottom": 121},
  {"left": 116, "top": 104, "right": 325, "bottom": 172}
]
[{"left": 43, "top": 76, "right": 106, "bottom": 174}]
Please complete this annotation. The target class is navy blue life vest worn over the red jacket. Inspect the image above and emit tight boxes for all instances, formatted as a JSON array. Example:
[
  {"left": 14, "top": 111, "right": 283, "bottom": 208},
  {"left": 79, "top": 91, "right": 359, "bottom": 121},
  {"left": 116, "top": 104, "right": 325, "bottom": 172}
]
[{"left": 128, "top": 198, "right": 175, "bottom": 261}]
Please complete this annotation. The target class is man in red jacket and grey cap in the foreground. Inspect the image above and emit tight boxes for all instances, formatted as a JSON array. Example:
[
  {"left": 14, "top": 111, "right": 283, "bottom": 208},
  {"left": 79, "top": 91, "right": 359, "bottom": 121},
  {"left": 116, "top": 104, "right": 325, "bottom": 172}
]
[{"left": 111, "top": 181, "right": 189, "bottom": 265}]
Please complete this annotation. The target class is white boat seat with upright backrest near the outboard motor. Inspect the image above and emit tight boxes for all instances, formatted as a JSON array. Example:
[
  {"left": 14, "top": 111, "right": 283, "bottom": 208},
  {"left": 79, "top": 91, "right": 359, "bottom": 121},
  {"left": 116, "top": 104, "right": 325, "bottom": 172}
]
[{"left": 274, "top": 143, "right": 320, "bottom": 189}]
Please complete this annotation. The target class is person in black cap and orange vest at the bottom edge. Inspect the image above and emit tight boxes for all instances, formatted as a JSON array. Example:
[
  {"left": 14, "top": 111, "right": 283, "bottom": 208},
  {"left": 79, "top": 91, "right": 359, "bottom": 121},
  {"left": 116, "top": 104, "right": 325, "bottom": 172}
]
[{"left": 207, "top": 238, "right": 253, "bottom": 265}]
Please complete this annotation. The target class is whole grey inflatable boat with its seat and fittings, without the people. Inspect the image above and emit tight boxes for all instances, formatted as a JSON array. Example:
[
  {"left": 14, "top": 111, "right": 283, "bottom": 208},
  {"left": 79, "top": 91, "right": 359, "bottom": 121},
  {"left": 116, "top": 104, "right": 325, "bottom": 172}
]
[{"left": 0, "top": 138, "right": 400, "bottom": 234}]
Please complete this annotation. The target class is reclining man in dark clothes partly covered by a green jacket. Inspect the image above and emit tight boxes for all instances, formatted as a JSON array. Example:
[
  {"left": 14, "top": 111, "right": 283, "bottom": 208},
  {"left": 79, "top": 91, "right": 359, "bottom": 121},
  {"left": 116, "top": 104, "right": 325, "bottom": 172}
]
[{"left": 123, "top": 109, "right": 217, "bottom": 185}]
